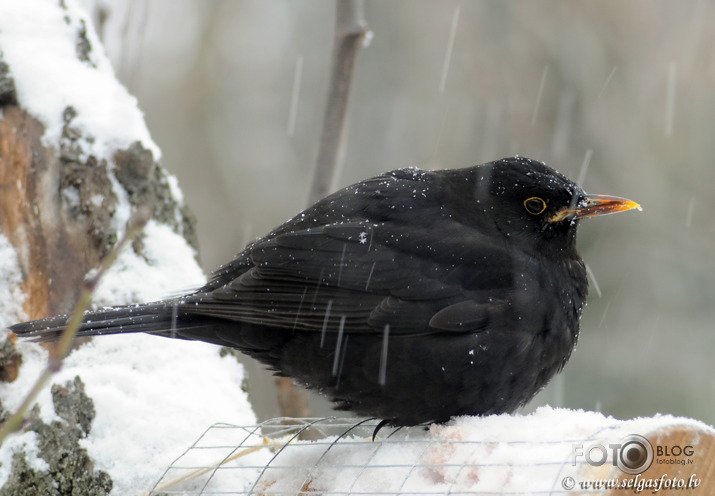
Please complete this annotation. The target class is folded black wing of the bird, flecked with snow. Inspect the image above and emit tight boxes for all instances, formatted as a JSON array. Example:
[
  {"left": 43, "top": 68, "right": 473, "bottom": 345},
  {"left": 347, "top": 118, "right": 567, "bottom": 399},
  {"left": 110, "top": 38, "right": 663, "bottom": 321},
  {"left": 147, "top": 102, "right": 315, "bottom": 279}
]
[{"left": 182, "top": 222, "right": 524, "bottom": 335}]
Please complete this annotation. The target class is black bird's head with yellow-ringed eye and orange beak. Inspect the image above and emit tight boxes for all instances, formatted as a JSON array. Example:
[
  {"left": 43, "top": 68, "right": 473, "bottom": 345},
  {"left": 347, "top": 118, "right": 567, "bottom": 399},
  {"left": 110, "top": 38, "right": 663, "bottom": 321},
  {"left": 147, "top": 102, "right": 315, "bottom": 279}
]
[{"left": 458, "top": 157, "right": 640, "bottom": 256}]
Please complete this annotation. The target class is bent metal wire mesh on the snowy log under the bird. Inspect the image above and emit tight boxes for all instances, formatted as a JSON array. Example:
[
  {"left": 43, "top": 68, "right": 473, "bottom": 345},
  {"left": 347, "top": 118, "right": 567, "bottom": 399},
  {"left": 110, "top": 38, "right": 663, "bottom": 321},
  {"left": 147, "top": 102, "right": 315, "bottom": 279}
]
[{"left": 145, "top": 417, "right": 608, "bottom": 496}]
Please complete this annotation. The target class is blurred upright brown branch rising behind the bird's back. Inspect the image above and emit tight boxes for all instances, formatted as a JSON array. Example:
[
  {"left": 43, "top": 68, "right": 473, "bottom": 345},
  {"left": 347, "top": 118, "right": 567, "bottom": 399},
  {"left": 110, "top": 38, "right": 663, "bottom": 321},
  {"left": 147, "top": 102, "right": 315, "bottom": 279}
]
[{"left": 308, "top": 0, "right": 368, "bottom": 204}]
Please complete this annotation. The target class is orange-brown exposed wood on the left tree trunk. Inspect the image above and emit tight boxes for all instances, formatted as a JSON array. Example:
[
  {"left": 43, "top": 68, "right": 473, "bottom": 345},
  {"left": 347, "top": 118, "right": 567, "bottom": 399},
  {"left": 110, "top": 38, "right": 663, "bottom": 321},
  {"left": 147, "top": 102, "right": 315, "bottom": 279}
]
[{"left": 0, "top": 104, "right": 101, "bottom": 319}]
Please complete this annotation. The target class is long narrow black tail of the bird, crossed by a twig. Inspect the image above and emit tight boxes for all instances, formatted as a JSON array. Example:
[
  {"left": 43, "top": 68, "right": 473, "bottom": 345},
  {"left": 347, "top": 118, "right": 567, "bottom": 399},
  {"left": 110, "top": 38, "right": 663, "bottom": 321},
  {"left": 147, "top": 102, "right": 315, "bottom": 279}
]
[{"left": 9, "top": 302, "right": 184, "bottom": 341}]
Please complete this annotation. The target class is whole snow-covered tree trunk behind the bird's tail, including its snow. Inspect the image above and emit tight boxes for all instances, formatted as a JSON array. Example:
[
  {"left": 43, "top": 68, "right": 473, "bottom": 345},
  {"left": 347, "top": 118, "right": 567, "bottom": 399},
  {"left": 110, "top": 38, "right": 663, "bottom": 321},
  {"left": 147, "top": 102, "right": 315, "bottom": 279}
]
[{"left": 0, "top": 0, "right": 255, "bottom": 495}]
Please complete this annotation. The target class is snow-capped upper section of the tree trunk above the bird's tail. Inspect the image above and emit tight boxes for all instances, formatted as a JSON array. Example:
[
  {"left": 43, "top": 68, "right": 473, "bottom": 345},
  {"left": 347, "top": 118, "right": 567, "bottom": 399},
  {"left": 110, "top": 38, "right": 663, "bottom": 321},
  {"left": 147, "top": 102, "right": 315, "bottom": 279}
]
[{"left": 0, "top": 6, "right": 194, "bottom": 319}]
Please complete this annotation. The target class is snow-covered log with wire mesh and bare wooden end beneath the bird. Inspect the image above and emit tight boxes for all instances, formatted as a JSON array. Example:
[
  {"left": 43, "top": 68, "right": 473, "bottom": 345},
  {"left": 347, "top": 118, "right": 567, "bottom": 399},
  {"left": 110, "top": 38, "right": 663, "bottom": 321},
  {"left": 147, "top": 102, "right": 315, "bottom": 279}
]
[{"left": 151, "top": 407, "right": 715, "bottom": 496}]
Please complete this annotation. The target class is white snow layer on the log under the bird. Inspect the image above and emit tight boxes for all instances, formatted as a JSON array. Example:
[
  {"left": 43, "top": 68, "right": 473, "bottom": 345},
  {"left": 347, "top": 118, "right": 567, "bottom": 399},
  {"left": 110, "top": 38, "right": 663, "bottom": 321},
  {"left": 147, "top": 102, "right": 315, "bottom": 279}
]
[{"left": 148, "top": 407, "right": 715, "bottom": 495}]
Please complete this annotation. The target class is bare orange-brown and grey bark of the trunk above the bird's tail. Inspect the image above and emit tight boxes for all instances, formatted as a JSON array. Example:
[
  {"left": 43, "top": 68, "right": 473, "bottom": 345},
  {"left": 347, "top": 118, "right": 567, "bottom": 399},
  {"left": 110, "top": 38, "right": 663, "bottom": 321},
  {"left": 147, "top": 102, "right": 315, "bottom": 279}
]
[{"left": 0, "top": 90, "right": 199, "bottom": 319}]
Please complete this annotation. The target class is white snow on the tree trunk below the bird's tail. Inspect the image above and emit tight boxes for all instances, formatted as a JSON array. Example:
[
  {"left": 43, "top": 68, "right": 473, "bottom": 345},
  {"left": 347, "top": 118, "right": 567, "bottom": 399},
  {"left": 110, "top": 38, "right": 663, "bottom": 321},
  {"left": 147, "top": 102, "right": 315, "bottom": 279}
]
[{"left": 0, "top": 335, "right": 255, "bottom": 495}]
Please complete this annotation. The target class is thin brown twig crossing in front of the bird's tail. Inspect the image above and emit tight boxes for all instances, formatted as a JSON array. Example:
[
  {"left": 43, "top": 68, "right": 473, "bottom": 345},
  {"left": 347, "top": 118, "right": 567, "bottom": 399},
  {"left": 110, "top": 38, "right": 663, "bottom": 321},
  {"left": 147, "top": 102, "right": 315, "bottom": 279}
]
[{"left": 0, "top": 207, "right": 151, "bottom": 446}]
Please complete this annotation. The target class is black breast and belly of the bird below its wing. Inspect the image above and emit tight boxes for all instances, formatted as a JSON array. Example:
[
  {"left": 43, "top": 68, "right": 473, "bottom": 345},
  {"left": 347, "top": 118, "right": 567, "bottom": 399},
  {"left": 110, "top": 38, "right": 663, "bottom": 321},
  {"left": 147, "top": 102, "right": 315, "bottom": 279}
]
[{"left": 270, "top": 256, "right": 585, "bottom": 425}]
